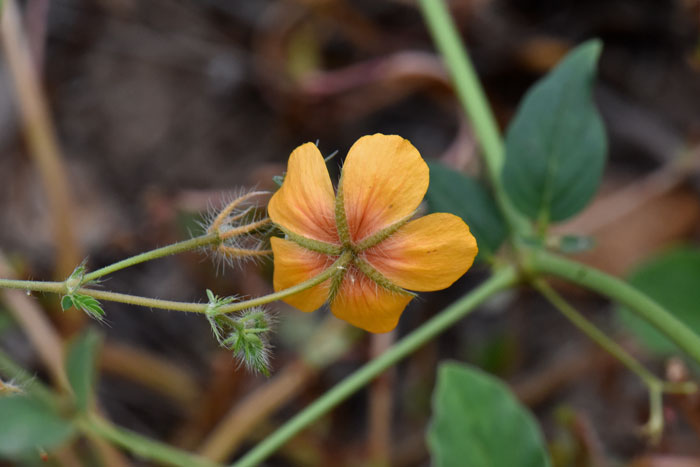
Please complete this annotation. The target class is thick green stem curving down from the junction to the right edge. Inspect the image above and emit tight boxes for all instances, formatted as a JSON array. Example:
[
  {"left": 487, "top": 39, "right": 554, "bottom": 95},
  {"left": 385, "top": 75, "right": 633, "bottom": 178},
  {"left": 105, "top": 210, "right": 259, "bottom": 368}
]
[{"left": 529, "top": 250, "right": 700, "bottom": 363}]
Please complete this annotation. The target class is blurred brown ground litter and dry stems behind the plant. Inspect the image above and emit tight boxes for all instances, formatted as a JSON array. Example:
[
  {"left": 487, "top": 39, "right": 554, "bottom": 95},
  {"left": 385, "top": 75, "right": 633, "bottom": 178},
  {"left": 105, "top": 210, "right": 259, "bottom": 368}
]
[{"left": 0, "top": 0, "right": 700, "bottom": 466}]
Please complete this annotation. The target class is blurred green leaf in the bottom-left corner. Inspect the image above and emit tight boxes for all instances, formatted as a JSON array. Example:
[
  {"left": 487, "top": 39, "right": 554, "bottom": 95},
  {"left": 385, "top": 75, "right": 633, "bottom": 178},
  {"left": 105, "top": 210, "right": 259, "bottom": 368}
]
[{"left": 0, "top": 396, "right": 74, "bottom": 458}]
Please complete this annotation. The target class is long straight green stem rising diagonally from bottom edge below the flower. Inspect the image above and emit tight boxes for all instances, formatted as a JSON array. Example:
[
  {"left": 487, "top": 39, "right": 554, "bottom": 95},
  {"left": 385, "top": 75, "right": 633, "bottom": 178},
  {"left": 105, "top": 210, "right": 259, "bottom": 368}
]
[{"left": 233, "top": 267, "right": 518, "bottom": 467}]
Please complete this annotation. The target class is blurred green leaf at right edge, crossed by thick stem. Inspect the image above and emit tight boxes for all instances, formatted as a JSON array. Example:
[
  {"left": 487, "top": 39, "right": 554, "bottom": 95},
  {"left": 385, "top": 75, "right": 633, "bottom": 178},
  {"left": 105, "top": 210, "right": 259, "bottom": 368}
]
[{"left": 618, "top": 247, "right": 700, "bottom": 355}]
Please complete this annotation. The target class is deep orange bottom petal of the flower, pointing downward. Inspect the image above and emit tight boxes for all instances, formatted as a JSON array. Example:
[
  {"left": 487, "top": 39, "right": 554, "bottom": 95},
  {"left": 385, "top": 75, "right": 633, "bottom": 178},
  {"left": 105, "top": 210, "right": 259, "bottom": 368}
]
[{"left": 331, "top": 267, "right": 412, "bottom": 332}]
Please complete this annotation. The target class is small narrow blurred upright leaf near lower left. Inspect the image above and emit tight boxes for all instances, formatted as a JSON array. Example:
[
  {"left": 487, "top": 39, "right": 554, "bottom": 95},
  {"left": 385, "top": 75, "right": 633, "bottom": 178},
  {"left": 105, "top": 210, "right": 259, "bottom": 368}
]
[{"left": 66, "top": 330, "right": 100, "bottom": 411}]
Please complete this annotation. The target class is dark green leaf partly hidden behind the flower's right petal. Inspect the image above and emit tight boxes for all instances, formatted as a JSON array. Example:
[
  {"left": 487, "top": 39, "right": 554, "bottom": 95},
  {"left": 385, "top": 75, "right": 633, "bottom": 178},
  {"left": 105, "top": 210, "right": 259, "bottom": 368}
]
[{"left": 426, "top": 162, "right": 508, "bottom": 259}]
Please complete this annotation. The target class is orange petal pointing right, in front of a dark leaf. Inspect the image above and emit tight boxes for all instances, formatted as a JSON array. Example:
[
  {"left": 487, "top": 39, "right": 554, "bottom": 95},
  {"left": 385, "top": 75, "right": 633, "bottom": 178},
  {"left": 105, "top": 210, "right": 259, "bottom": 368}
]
[{"left": 363, "top": 213, "right": 479, "bottom": 291}]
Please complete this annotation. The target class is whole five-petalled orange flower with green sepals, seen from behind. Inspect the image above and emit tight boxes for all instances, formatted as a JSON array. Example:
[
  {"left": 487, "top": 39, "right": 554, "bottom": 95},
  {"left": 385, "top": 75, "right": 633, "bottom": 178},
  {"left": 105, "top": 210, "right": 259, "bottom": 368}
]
[{"left": 268, "top": 134, "right": 478, "bottom": 332}]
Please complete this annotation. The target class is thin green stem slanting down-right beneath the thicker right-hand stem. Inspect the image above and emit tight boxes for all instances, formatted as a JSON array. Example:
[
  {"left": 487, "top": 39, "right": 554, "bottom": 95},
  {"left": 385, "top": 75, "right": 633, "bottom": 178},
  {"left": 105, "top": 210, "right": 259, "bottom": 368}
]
[{"left": 532, "top": 280, "right": 663, "bottom": 391}]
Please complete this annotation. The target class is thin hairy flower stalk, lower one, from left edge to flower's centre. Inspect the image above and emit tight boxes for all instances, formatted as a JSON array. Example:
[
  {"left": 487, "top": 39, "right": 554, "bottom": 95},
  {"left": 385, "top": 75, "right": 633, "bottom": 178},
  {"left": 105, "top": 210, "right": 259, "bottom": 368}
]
[{"left": 0, "top": 252, "right": 351, "bottom": 315}]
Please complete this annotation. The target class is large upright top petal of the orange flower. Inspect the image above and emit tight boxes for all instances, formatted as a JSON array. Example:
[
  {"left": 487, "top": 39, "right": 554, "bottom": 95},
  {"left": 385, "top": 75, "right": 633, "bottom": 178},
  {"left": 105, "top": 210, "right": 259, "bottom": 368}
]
[{"left": 343, "top": 134, "right": 429, "bottom": 242}]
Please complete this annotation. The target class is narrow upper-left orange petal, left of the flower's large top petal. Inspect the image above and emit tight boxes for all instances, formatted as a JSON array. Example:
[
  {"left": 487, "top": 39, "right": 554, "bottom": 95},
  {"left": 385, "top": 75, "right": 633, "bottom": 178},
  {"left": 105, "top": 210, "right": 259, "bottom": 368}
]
[{"left": 267, "top": 143, "right": 339, "bottom": 244}]
